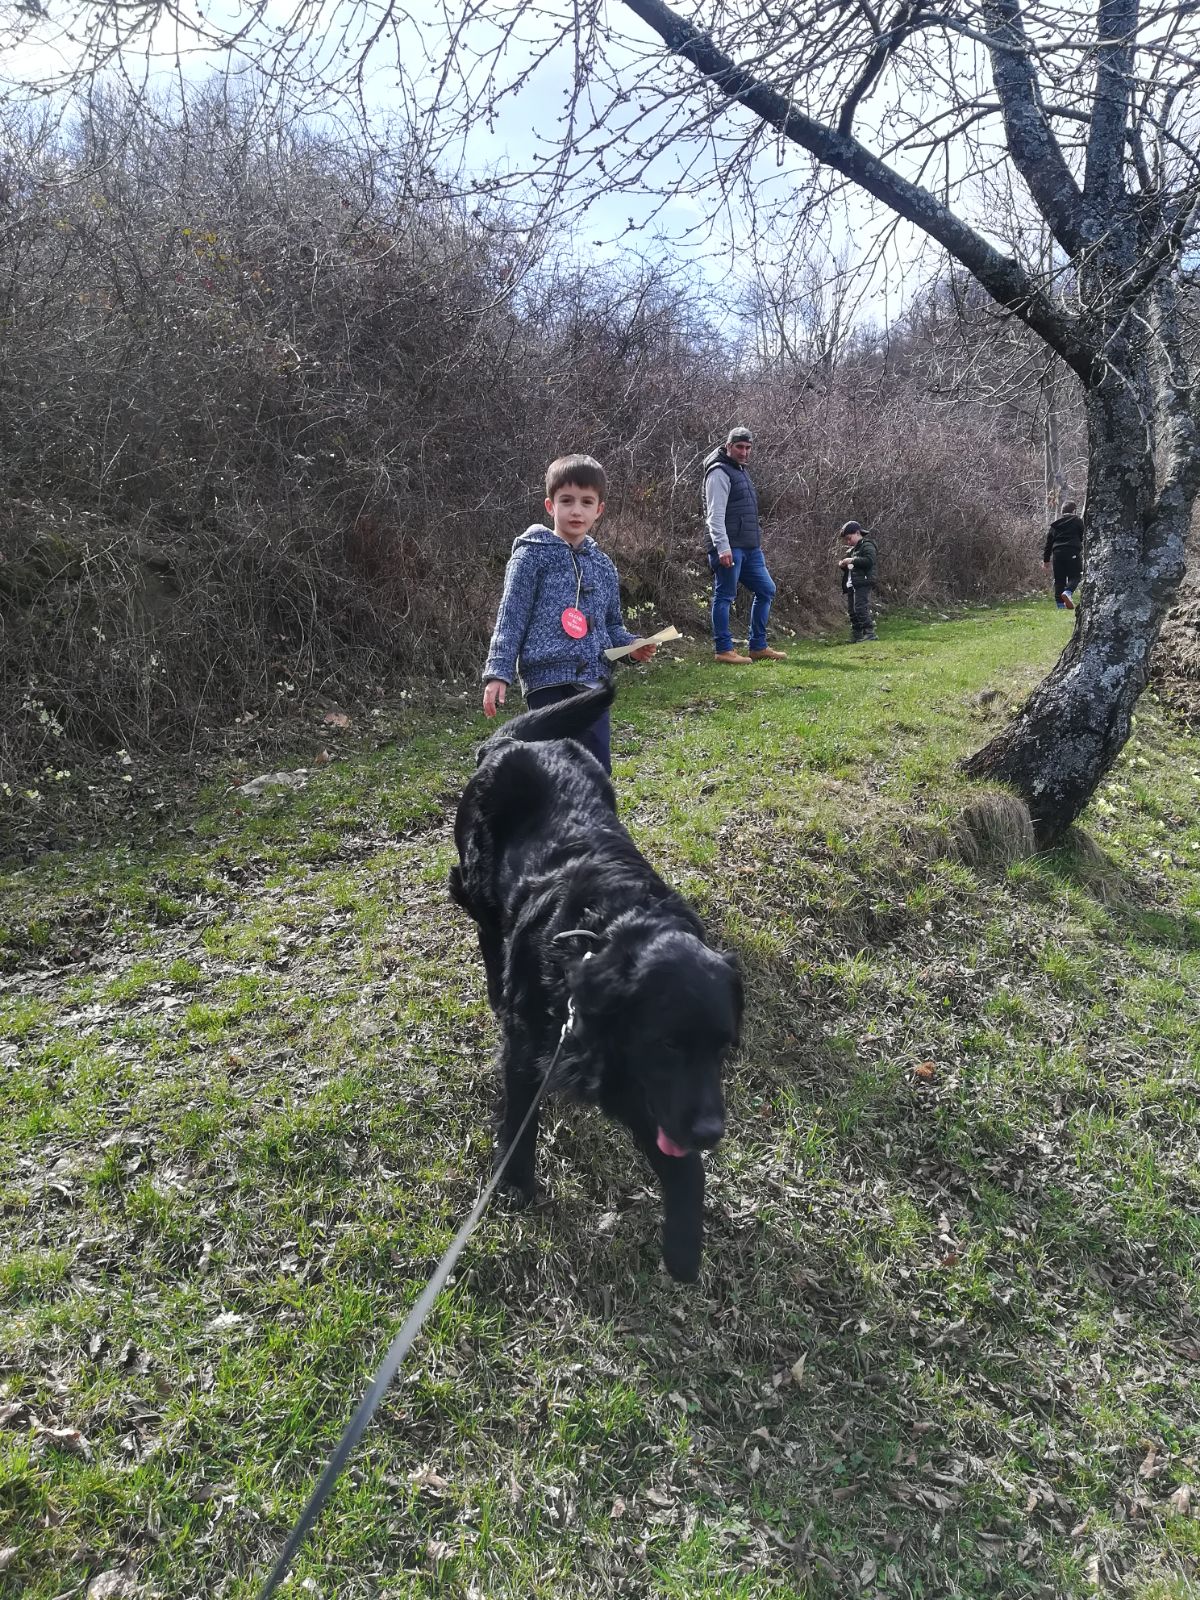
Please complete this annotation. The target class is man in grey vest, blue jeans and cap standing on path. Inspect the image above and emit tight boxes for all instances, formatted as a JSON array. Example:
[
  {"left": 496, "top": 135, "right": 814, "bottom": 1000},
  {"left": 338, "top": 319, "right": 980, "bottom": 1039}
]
[{"left": 704, "top": 427, "right": 787, "bottom": 667}]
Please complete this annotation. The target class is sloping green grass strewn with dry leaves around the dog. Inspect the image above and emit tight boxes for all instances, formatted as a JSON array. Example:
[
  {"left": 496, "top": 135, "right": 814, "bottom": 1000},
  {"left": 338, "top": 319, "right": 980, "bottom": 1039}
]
[{"left": 0, "top": 605, "right": 1200, "bottom": 1600}]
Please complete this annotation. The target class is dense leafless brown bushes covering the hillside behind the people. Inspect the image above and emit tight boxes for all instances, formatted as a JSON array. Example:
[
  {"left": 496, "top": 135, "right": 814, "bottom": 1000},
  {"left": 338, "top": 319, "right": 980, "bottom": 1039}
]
[{"left": 0, "top": 91, "right": 1032, "bottom": 778}]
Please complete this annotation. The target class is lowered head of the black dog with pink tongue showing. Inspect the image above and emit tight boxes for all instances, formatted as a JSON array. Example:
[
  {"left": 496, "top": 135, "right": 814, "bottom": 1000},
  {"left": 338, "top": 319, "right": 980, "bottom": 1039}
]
[{"left": 571, "top": 922, "right": 742, "bottom": 1155}]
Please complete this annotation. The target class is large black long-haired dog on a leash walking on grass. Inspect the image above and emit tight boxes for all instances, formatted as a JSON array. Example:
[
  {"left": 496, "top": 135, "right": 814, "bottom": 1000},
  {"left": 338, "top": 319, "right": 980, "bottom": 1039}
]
[{"left": 450, "top": 686, "right": 742, "bottom": 1282}]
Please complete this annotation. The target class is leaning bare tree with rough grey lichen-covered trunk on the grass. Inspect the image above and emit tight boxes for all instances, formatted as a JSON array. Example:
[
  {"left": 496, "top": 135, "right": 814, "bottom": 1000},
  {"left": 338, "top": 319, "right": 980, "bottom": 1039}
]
[{"left": 531, "top": 0, "right": 1200, "bottom": 845}]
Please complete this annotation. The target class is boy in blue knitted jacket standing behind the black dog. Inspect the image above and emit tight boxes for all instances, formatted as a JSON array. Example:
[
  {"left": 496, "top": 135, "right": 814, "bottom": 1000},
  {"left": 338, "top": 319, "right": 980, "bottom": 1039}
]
[{"left": 483, "top": 456, "right": 656, "bottom": 773}]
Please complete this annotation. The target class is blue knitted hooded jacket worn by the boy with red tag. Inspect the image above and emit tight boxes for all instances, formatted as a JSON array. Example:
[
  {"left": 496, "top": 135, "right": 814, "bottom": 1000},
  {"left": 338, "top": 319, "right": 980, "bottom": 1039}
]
[{"left": 483, "top": 523, "right": 637, "bottom": 694}]
